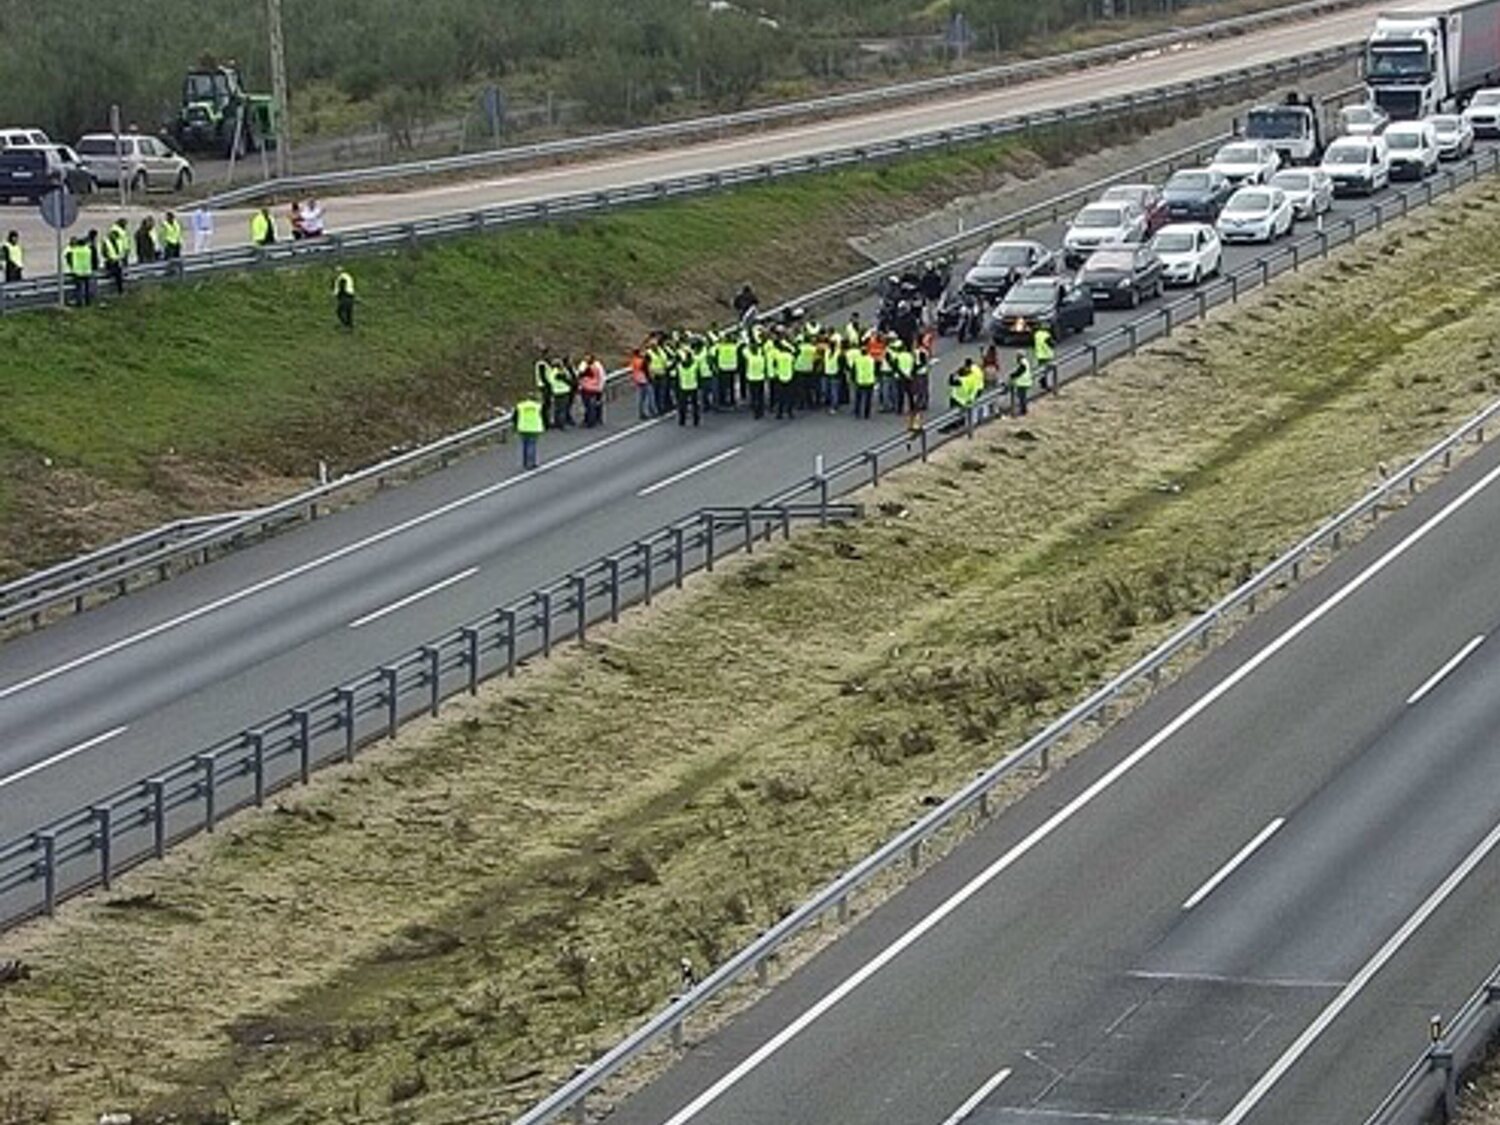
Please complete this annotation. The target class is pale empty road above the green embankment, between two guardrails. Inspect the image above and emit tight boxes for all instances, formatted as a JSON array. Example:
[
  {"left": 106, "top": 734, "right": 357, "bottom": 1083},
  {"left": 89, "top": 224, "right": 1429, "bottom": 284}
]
[{"left": 3, "top": 0, "right": 1448, "bottom": 272}]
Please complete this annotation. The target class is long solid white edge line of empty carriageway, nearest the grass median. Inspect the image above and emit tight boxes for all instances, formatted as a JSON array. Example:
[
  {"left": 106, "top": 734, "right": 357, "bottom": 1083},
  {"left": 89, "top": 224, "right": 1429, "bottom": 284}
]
[{"left": 666, "top": 465, "right": 1500, "bottom": 1125}]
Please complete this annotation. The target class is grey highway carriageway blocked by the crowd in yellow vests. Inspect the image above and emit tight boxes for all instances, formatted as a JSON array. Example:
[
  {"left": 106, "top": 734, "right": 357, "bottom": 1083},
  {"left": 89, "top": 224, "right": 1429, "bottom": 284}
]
[{"left": 0, "top": 152, "right": 1476, "bottom": 842}]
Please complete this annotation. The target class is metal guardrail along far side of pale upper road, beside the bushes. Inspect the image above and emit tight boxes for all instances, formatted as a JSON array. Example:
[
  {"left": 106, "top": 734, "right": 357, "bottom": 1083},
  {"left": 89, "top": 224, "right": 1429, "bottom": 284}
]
[{"left": 190, "top": 0, "right": 1367, "bottom": 207}]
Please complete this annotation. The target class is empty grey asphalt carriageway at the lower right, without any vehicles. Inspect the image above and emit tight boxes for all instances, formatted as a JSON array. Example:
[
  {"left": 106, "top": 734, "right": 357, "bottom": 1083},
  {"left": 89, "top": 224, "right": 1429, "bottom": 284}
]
[{"left": 596, "top": 435, "right": 1500, "bottom": 1125}]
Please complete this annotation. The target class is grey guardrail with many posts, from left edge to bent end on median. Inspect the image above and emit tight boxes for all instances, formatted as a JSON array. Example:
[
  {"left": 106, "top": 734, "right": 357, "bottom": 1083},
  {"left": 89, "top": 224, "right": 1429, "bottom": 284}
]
[{"left": 0, "top": 504, "right": 863, "bottom": 929}]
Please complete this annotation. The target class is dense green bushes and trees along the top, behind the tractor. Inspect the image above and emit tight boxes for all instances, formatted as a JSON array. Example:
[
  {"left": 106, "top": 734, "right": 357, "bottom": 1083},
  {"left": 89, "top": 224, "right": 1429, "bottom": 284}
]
[{"left": 0, "top": 0, "right": 1200, "bottom": 137}]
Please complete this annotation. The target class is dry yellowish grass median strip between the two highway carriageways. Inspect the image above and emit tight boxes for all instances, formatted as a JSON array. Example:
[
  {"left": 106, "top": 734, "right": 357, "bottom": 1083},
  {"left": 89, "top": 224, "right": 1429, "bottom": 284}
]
[{"left": 0, "top": 185, "right": 1500, "bottom": 1122}]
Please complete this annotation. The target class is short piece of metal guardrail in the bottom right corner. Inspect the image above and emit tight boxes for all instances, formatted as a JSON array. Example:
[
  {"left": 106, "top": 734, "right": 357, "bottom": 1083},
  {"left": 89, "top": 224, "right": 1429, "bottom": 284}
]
[{"left": 1365, "top": 965, "right": 1500, "bottom": 1125}]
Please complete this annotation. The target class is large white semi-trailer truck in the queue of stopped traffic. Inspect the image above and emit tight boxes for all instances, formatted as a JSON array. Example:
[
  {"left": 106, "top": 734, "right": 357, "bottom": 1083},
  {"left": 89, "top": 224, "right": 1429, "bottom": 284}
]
[{"left": 1364, "top": 0, "right": 1500, "bottom": 122}]
